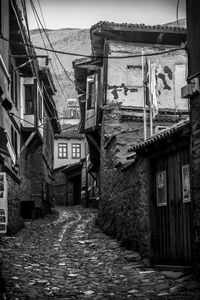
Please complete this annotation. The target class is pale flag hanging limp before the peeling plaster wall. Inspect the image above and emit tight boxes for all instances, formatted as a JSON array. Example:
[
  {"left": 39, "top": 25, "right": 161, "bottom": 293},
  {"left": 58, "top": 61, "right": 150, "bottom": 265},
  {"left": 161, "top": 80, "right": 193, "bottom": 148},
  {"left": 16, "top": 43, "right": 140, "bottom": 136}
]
[{"left": 150, "top": 64, "right": 158, "bottom": 118}]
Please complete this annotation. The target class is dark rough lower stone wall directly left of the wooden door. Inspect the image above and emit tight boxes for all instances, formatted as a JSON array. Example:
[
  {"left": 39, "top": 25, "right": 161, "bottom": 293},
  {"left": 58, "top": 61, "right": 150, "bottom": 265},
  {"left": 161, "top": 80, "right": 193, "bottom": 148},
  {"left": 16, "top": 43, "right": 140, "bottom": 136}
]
[{"left": 99, "top": 149, "right": 150, "bottom": 257}]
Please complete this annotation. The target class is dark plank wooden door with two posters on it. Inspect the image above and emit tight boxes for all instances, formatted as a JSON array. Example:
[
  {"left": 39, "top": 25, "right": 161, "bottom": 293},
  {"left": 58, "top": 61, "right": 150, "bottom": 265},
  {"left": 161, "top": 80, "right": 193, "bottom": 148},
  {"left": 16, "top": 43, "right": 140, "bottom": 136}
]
[{"left": 150, "top": 148, "right": 192, "bottom": 265}]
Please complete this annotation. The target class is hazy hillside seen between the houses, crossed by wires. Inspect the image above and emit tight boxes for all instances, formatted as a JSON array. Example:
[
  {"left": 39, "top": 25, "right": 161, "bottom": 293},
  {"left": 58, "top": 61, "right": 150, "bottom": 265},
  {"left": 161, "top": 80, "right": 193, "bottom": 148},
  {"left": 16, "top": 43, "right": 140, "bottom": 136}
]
[{"left": 31, "top": 28, "right": 91, "bottom": 112}]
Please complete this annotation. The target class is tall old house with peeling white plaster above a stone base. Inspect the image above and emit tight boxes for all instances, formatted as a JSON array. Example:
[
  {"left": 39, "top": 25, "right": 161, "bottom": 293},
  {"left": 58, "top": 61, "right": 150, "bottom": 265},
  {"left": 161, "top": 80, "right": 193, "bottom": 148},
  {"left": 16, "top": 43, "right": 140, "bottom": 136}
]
[{"left": 73, "top": 22, "right": 188, "bottom": 257}]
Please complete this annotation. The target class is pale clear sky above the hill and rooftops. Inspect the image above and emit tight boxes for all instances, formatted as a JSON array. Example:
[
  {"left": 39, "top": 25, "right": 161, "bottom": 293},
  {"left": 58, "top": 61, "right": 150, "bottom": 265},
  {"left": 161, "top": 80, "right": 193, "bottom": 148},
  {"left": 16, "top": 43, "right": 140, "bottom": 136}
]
[{"left": 26, "top": 0, "right": 186, "bottom": 29}]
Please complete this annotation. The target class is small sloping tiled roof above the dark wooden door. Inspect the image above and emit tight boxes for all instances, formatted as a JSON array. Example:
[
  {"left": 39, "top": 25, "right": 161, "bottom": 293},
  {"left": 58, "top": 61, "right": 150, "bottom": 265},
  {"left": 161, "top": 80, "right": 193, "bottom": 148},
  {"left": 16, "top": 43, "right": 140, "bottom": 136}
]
[{"left": 128, "top": 119, "right": 190, "bottom": 152}]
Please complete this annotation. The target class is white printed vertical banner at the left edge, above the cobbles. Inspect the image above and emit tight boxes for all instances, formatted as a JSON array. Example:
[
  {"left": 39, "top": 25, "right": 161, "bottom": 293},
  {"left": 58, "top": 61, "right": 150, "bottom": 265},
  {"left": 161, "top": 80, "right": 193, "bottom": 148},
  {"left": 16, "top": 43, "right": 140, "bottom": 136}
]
[{"left": 0, "top": 172, "right": 8, "bottom": 233}]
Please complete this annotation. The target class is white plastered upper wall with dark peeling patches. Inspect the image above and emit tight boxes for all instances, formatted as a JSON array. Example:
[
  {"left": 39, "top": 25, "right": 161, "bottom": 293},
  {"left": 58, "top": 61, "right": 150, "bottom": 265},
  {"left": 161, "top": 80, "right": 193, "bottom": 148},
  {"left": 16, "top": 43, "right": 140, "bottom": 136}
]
[{"left": 107, "top": 41, "right": 188, "bottom": 110}]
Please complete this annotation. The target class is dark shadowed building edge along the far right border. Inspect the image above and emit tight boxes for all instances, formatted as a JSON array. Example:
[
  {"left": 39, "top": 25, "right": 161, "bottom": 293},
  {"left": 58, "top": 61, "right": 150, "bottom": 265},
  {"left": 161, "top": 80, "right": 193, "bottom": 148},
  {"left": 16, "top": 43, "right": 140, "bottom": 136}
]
[{"left": 187, "top": 0, "right": 200, "bottom": 276}]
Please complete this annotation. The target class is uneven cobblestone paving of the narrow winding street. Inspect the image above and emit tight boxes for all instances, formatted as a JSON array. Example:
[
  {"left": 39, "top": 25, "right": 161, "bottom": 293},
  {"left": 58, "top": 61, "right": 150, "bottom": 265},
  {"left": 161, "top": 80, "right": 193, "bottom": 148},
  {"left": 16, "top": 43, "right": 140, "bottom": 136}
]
[{"left": 1, "top": 206, "right": 200, "bottom": 300}]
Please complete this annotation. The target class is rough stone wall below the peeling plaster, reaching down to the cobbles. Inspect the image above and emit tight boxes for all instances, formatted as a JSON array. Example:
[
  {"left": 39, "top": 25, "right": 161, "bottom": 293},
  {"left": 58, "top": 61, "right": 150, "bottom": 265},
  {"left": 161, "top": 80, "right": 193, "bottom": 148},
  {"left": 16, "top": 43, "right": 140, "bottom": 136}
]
[{"left": 99, "top": 106, "right": 150, "bottom": 257}]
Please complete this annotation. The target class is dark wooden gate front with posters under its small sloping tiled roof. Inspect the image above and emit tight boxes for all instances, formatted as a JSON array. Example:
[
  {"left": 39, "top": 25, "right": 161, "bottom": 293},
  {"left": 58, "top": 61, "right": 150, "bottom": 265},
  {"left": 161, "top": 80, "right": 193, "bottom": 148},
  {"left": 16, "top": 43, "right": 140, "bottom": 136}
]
[{"left": 134, "top": 121, "right": 191, "bottom": 265}]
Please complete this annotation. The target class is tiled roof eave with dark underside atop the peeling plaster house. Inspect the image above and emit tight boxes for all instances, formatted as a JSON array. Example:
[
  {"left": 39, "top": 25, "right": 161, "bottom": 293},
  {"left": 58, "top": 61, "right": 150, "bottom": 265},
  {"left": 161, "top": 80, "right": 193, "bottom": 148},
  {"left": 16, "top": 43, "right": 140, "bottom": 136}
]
[{"left": 90, "top": 22, "right": 187, "bottom": 58}]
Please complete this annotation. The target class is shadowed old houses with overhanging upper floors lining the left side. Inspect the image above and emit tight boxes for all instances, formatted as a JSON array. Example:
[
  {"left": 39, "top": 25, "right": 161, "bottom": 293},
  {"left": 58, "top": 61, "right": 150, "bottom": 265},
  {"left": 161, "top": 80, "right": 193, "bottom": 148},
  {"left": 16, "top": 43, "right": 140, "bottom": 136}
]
[{"left": 0, "top": 0, "right": 59, "bottom": 232}]
